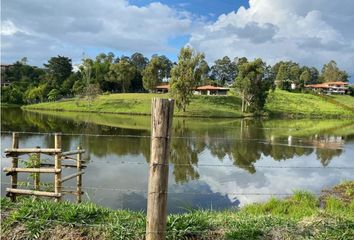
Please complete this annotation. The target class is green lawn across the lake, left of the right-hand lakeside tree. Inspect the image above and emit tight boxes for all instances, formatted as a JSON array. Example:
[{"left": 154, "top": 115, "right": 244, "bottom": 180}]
[{"left": 25, "top": 93, "right": 242, "bottom": 117}]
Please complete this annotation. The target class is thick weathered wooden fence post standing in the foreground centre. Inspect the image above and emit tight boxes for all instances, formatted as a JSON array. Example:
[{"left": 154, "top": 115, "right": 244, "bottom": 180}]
[{"left": 146, "top": 98, "right": 174, "bottom": 240}]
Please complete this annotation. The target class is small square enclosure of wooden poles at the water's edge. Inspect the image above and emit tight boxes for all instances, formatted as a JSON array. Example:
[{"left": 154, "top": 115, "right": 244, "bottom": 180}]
[{"left": 4, "top": 132, "right": 86, "bottom": 202}]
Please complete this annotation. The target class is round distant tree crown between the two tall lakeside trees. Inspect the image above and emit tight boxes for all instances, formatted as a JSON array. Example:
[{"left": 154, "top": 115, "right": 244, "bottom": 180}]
[{"left": 211, "top": 56, "right": 236, "bottom": 85}]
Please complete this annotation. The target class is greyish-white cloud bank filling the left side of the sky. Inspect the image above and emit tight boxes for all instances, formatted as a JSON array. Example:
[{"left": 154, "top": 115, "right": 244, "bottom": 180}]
[{"left": 1, "top": 0, "right": 198, "bottom": 64}]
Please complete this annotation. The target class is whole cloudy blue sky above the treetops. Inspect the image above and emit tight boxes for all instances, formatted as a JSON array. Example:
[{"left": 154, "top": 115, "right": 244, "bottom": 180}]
[{"left": 1, "top": 0, "right": 354, "bottom": 80}]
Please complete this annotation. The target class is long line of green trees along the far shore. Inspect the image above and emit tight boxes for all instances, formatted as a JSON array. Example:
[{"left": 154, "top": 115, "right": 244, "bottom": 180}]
[{"left": 1, "top": 47, "right": 349, "bottom": 112}]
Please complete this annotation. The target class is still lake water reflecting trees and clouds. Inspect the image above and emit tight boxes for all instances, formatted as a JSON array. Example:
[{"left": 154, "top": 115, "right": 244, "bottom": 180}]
[{"left": 1, "top": 108, "right": 354, "bottom": 212}]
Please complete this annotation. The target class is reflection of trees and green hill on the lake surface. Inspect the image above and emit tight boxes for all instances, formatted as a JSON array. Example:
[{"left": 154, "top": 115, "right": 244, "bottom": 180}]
[{"left": 1, "top": 108, "right": 354, "bottom": 184}]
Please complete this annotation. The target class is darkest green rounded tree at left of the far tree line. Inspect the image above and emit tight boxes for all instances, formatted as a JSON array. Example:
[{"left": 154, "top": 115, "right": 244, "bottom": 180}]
[{"left": 44, "top": 55, "right": 73, "bottom": 87}]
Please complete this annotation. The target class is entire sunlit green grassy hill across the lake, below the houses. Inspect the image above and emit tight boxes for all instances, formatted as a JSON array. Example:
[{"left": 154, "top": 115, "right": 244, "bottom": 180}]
[{"left": 24, "top": 90, "right": 354, "bottom": 118}]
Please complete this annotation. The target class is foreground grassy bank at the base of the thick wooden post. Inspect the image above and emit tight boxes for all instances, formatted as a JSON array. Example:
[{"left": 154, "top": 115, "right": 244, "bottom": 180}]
[{"left": 1, "top": 181, "right": 354, "bottom": 240}]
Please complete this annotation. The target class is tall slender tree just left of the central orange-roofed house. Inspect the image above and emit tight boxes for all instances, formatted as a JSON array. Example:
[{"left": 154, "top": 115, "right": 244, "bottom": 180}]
[{"left": 170, "top": 47, "right": 204, "bottom": 112}]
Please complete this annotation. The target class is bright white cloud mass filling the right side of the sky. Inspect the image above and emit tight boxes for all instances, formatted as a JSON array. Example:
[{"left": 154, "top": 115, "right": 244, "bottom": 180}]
[{"left": 189, "top": 0, "right": 354, "bottom": 73}]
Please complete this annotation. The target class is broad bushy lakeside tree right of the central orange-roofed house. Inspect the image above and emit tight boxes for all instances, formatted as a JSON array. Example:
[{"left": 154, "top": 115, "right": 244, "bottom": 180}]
[{"left": 234, "top": 58, "right": 272, "bottom": 112}]
